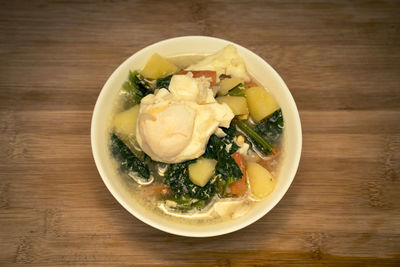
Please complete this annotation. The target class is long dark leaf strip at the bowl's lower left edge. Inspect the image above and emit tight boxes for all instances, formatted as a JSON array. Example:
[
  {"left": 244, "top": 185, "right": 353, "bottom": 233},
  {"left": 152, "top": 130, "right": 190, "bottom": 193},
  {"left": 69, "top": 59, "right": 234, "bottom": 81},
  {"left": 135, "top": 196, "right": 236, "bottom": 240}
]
[{"left": 111, "top": 134, "right": 150, "bottom": 180}]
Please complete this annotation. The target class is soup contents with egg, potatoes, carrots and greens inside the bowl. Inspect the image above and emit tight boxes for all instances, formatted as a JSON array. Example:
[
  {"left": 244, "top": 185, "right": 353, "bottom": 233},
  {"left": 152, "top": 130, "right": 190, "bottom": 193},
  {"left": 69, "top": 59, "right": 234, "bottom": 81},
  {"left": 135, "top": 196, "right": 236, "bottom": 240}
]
[{"left": 109, "top": 45, "right": 284, "bottom": 223}]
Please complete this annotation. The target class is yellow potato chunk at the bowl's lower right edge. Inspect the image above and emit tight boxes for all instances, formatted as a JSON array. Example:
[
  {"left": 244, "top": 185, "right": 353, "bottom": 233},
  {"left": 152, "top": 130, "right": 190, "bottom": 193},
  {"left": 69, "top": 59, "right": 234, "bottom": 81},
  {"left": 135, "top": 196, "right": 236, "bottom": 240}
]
[{"left": 246, "top": 162, "right": 276, "bottom": 198}]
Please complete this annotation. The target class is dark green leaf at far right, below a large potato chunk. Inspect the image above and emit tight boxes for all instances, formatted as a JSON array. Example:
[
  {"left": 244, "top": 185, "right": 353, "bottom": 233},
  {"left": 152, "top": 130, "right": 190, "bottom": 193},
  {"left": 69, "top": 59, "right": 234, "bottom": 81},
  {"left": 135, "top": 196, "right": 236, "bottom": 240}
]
[{"left": 256, "top": 109, "right": 284, "bottom": 143}]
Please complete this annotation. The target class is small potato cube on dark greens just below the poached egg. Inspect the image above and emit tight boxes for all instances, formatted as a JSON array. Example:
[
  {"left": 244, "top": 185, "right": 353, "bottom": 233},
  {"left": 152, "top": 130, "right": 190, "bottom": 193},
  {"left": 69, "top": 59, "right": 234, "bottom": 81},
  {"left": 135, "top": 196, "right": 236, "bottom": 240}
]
[{"left": 189, "top": 158, "right": 217, "bottom": 187}]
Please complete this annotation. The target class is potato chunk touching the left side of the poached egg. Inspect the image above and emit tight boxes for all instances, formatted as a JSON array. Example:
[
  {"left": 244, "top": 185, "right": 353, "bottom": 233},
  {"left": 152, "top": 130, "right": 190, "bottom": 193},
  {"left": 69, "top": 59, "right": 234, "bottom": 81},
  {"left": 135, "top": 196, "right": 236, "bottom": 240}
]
[{"left": 114, "top": 105, "right": 140, "bottom": 139}]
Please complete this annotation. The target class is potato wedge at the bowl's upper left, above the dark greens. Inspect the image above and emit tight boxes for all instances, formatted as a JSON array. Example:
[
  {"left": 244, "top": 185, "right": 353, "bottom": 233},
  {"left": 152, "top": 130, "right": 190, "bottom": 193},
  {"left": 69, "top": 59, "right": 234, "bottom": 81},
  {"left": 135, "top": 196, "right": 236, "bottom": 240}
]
[{"left": 140, "top": 53, "right": 179, "bottom": 79}]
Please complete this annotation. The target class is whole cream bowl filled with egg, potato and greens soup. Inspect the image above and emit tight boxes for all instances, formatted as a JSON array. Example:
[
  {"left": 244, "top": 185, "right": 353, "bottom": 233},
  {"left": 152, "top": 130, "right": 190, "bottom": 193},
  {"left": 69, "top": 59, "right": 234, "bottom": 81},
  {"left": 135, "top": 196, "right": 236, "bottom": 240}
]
[{"left": 91, "top": 36, "right": 301, "bottom": 237}]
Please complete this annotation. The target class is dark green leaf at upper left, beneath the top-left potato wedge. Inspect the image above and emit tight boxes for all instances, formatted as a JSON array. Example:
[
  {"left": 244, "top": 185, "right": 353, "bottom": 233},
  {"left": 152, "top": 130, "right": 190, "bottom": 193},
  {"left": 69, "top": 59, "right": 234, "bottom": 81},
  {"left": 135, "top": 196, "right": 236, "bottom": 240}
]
[{"left": 122, "top": 71, "right": 154, "bottom": 104}]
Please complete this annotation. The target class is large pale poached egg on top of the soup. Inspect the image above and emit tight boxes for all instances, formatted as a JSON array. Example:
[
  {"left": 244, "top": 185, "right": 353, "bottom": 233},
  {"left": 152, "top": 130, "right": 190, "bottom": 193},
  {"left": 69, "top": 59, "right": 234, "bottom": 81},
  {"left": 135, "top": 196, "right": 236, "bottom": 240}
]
[{"left": 136, "top": 72, "right": 234, "bottom": 163}]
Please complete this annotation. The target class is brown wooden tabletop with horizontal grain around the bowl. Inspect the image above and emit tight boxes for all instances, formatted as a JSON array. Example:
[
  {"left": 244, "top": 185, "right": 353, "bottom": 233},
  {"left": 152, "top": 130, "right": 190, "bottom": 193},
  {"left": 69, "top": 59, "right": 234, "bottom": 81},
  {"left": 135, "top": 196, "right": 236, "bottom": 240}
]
[{"left": 0, "top": 0, "right": 400, "bottom": 266}]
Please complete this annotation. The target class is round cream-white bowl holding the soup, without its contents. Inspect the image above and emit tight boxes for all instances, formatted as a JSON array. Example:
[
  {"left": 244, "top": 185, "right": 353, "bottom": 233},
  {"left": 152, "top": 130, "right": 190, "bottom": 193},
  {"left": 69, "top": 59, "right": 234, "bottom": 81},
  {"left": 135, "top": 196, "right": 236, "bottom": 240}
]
[{"left": 91, "top": 36, "right": 302, "bottom": 237}]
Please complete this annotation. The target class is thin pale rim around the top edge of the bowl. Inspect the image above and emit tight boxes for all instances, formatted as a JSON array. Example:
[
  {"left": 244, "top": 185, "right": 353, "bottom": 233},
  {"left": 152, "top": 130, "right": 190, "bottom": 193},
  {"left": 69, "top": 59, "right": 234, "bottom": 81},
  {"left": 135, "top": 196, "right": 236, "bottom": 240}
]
[{"left": 90, "top": 35, "right": 302, "bottom": 237}]
